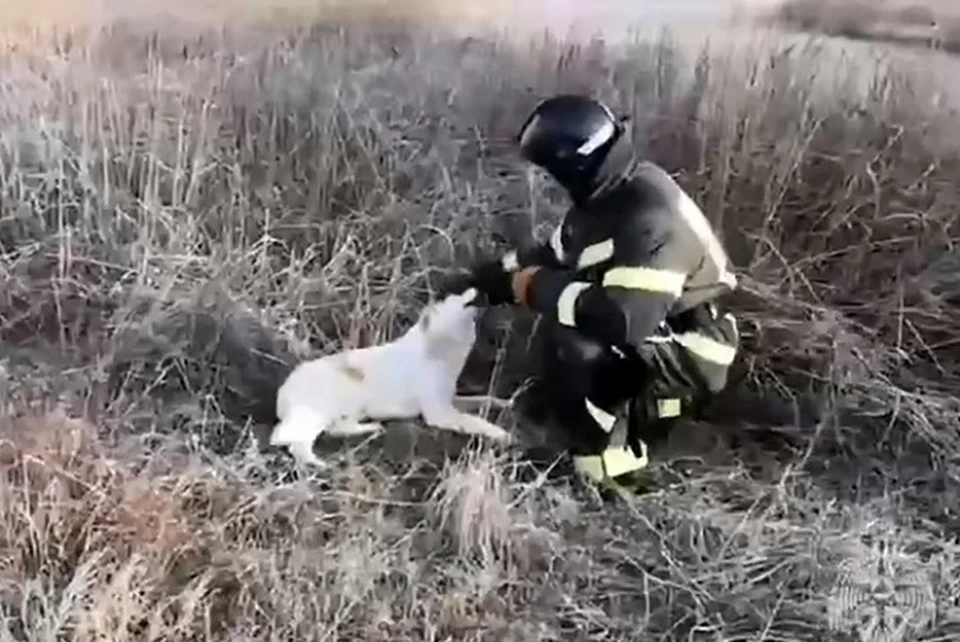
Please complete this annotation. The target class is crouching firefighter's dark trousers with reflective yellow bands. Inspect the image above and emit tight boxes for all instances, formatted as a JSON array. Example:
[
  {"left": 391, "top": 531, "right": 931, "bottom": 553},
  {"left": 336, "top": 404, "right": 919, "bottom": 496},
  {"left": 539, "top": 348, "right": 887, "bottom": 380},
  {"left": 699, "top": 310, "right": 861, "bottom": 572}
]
[{"left": 541, "top": 308, "right": 738, "bottom": 483}]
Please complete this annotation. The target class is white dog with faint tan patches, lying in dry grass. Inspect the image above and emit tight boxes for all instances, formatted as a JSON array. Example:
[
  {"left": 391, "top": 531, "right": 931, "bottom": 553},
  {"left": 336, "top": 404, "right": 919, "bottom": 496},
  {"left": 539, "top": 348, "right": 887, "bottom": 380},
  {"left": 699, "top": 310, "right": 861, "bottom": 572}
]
[{"left": 270, "top": 288, "right": 510, "bottom": 466}]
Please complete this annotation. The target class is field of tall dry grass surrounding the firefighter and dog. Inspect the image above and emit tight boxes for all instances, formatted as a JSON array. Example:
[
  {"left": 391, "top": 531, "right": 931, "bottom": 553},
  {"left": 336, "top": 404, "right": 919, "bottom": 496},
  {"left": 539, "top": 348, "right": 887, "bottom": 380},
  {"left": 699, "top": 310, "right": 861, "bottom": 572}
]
[{"left": 0, "top": 10, "right": 960, "bottom": 641}]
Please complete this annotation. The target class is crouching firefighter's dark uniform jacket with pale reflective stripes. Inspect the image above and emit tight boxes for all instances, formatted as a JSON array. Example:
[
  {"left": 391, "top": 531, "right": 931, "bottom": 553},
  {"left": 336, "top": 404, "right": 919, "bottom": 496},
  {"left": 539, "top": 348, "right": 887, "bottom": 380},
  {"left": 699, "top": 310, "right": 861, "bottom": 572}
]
[{"left": 503, "top": 147, "right": 738, "bottom": 393}]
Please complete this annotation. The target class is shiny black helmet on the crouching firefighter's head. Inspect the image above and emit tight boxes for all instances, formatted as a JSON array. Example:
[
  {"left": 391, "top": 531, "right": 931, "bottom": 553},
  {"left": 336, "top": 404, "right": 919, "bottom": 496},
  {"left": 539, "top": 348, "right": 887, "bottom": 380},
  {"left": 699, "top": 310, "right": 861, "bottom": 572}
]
[{"left": 517, "top": 94, "right": 624, "bottom": 200}]
